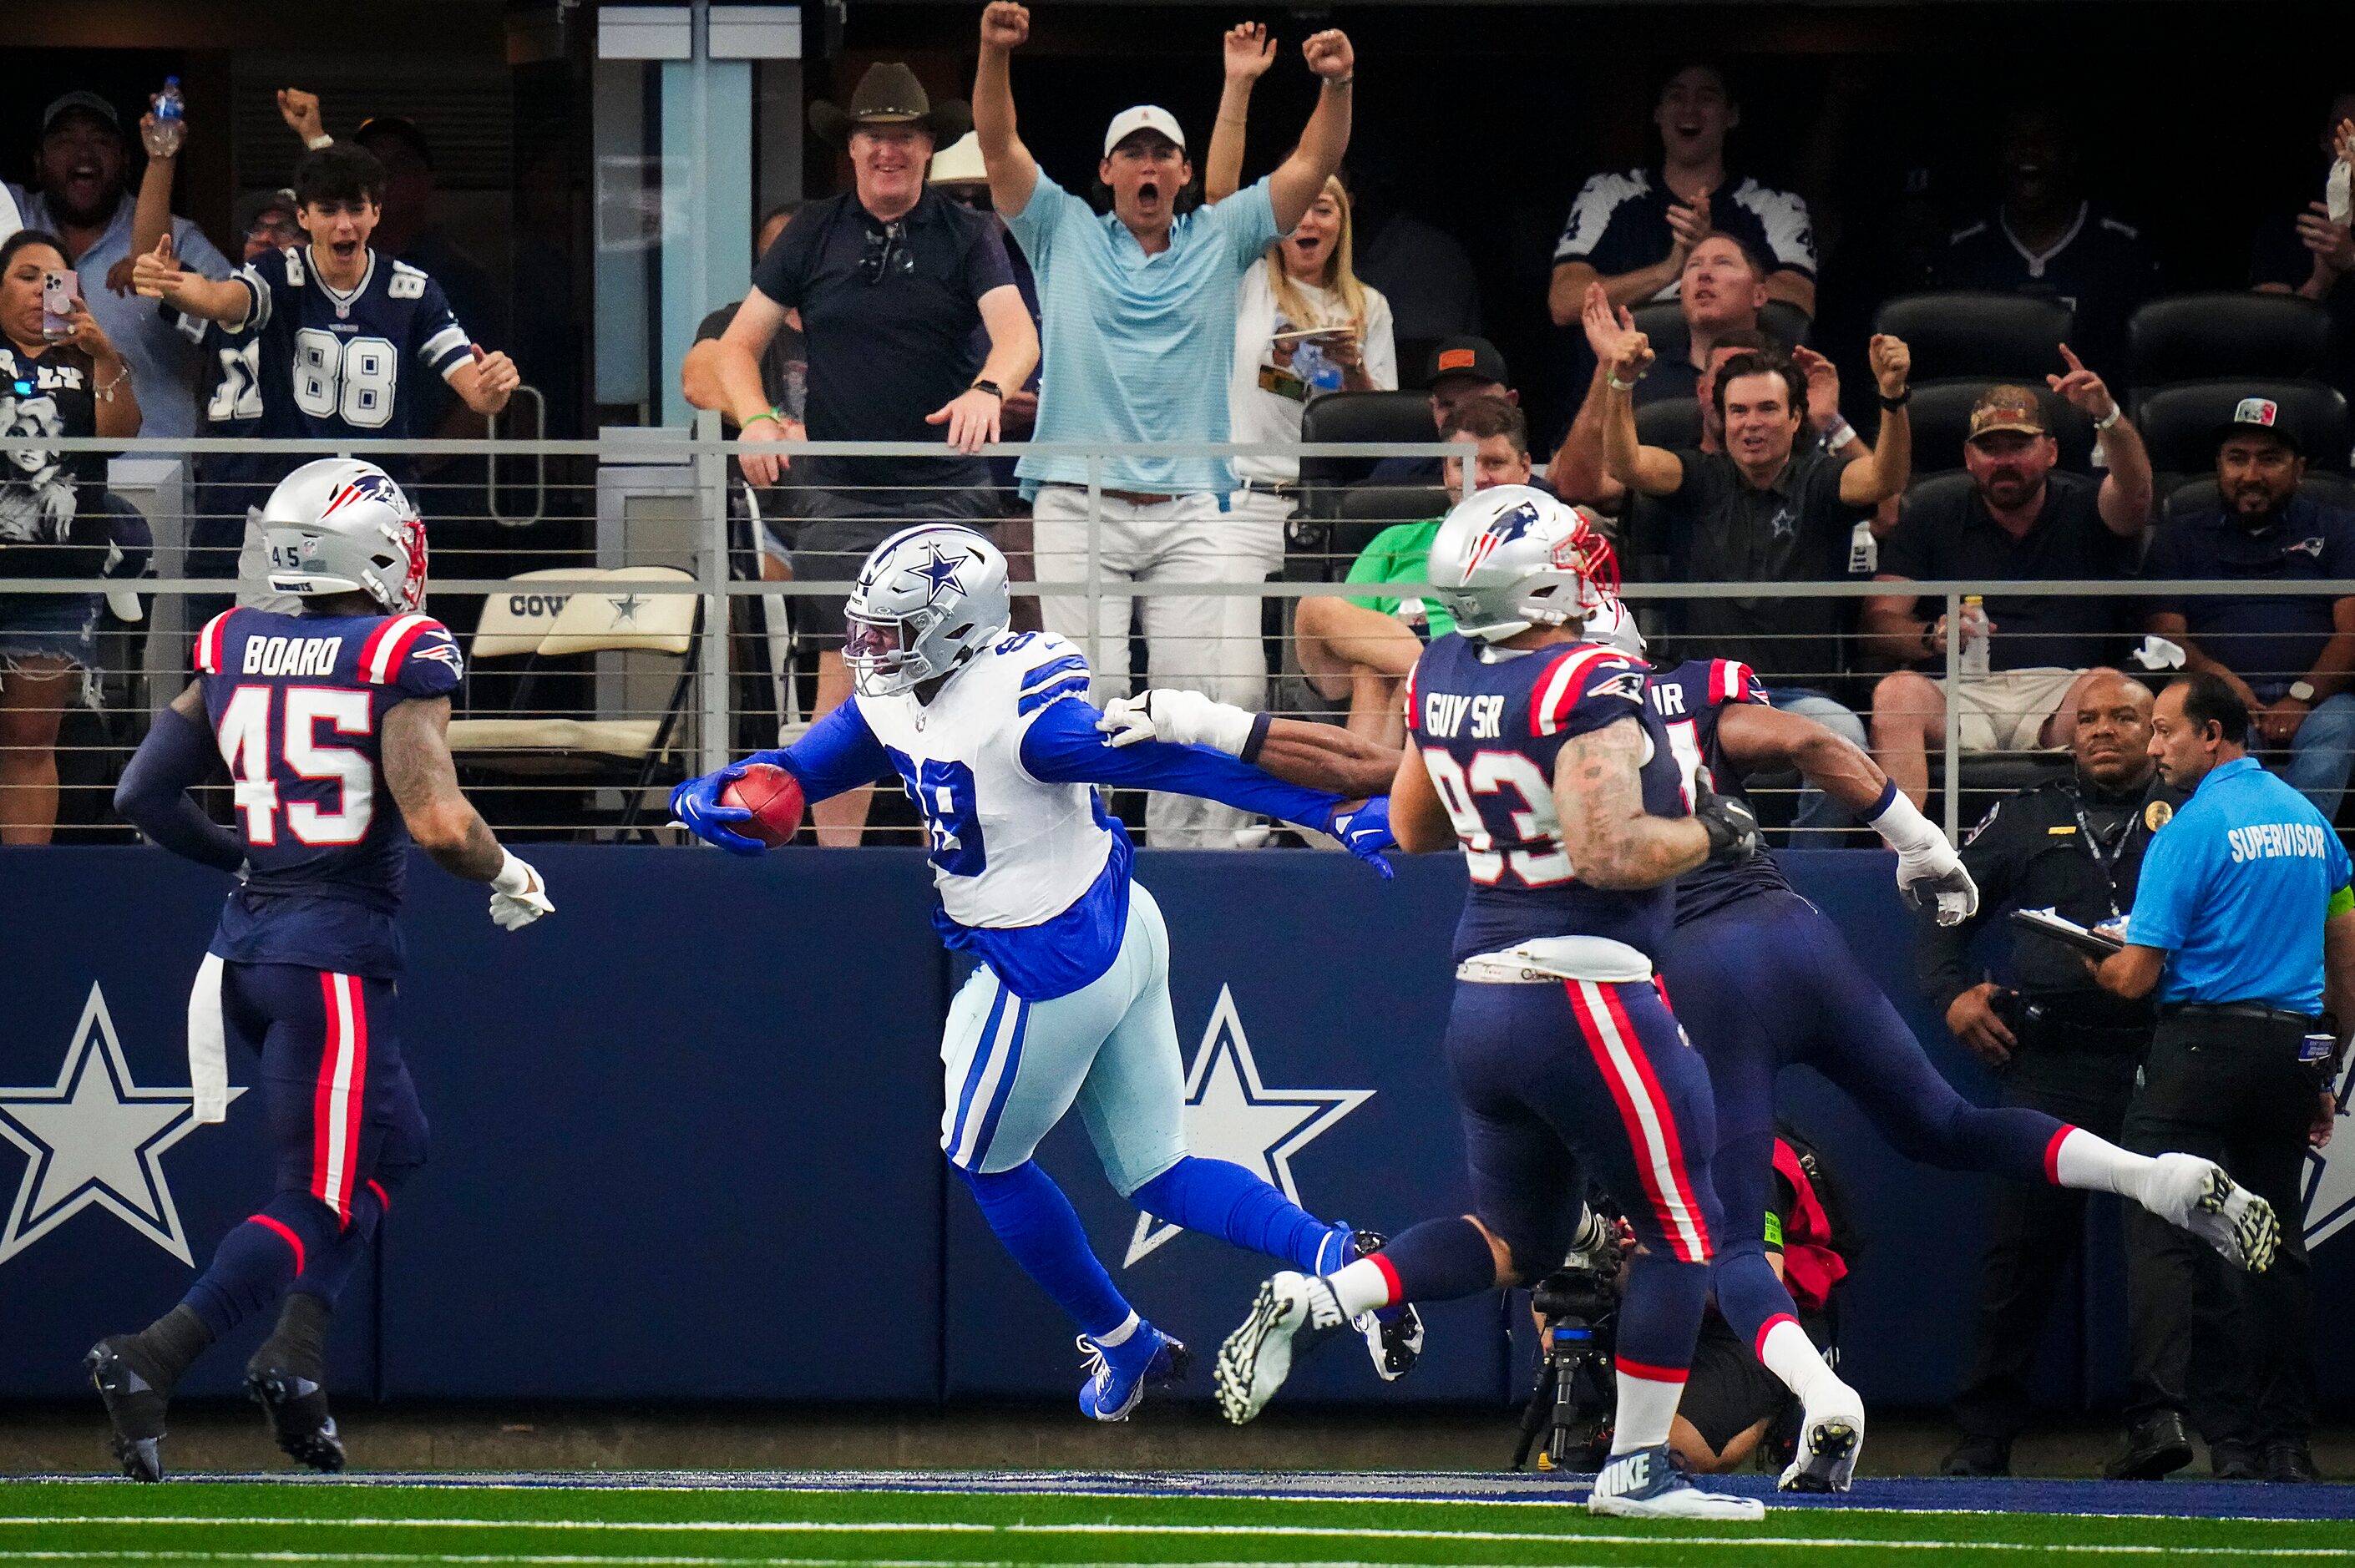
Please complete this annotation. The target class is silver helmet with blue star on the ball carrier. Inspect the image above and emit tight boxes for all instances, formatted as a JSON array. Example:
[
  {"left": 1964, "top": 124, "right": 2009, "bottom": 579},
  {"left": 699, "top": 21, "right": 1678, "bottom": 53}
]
[{"left": 843, "top": 523, "right": 1013, "bottom": 697}]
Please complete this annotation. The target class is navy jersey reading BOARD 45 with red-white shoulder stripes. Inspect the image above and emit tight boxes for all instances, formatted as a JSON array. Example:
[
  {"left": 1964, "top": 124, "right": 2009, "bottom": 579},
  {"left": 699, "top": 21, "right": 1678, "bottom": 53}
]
[{"left": 195, "top": 609, "right": 464, "bottom": 977}]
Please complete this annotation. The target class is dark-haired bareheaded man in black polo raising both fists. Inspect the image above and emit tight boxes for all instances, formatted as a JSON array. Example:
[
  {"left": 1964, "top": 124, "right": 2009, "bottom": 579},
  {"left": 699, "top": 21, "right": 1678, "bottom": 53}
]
[{"left": 1599, "top": 327, "right": 1912, "bottom": 827}]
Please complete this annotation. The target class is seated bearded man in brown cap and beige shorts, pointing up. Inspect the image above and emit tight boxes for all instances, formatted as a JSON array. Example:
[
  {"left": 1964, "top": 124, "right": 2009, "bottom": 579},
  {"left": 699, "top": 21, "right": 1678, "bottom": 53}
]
[{"left": 1861, "top": 367, "right": 2150, "bottom": 805}]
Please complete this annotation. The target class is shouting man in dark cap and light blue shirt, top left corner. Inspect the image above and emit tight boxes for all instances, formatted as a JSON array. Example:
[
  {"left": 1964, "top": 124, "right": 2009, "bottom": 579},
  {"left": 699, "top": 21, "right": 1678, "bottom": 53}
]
[{"left": 7, "top": 92, "right": 230, "bottom": 438}]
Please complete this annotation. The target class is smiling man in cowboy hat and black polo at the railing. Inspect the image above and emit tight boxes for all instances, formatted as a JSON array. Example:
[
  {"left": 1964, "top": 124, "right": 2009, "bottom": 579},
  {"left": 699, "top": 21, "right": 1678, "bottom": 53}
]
[{"left": 692, "top": 63, "right": 1039, "bottom": 845}]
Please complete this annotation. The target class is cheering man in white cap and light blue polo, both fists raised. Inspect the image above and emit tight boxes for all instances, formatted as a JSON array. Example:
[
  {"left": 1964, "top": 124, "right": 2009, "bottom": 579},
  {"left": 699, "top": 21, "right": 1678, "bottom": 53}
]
[{"left": 973, "top": 0, "right": 1356, "bottom": 845}]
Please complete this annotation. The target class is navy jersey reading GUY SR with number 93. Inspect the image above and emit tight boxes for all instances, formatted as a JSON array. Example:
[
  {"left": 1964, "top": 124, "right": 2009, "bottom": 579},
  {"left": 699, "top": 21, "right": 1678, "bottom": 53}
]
[{"left": 1406, "top": 634, "right": 1691, "bottom": 960}]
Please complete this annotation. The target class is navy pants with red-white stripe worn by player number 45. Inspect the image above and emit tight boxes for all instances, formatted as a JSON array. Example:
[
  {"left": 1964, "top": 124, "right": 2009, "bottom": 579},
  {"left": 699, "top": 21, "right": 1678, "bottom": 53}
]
[{"left": 186, "top": 963, "right": 426, "bottom": 1338}]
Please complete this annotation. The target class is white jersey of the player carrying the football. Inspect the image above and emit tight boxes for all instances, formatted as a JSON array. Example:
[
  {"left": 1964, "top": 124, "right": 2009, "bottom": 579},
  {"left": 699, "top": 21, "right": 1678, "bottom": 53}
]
[{"left": 853, "top": 631, "right": 1112, "bottom": 928}]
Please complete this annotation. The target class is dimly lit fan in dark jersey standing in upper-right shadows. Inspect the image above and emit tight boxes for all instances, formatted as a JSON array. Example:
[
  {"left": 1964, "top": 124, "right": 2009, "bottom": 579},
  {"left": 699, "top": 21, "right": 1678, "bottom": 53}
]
[{"left": 1933, "top": 106, "right": 2160, "bottom": 362}]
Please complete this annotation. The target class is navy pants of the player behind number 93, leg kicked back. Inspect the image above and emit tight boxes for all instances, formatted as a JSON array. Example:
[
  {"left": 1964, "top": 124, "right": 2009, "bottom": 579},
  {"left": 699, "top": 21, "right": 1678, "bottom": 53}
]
[{"left": 1663, "top": 893, "right": 2065, "bottom": 1349}]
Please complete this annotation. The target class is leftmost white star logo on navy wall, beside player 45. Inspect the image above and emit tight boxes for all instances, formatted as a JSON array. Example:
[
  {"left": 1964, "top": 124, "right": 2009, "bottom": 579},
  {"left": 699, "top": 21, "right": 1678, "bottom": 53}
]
[{"left": 0, "top": 982, "right": 245, "bottom": 1267}]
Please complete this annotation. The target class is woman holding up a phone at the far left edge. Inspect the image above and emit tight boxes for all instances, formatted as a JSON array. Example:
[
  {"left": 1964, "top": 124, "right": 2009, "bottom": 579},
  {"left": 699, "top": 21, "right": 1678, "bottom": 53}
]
[{"left": 0, "top": 229, "right": 139, "bottom": 845}]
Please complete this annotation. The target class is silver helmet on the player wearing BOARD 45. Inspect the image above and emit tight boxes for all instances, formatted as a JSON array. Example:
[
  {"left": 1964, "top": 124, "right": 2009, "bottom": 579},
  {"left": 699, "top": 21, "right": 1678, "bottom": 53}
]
[{"left": 261, "top": 457, "right": 426, "bottom": 615}]
